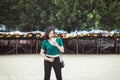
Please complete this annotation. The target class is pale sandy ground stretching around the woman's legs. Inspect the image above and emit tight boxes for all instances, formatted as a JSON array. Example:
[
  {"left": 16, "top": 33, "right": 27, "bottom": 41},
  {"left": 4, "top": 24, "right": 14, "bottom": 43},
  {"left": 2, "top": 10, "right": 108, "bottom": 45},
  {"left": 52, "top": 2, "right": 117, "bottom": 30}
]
[{"left": 0, "top": 54, "right": 120, "bottom": 80}]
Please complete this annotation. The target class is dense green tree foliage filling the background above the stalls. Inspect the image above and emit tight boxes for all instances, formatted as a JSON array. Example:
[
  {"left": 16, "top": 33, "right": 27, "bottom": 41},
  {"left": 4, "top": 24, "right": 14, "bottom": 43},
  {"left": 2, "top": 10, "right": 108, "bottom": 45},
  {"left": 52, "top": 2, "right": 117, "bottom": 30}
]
[{"left": 0, "top": 0, "right": 120, "bottom": 31}]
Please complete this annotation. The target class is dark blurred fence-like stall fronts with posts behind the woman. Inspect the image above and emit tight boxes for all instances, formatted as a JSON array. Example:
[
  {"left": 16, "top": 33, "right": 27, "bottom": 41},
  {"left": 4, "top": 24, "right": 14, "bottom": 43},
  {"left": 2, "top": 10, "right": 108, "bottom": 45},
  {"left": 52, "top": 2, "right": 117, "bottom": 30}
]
[{"left": 0, "top": 37, "right": 120, "bottom": 54}]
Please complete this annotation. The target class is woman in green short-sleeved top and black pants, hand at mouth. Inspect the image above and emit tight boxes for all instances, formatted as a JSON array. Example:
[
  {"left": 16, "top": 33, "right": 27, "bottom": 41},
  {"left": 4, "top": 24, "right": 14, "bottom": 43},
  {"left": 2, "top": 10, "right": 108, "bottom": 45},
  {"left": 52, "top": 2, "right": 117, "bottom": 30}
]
[{"left": 40, "top": 27, "right": 64, "bottom": 80}]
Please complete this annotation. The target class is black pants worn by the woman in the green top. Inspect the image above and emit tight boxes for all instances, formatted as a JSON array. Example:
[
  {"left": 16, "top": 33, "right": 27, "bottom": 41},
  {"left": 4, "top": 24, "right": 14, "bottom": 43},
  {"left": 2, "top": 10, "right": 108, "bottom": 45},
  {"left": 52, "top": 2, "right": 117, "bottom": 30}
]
[{"left": 44, "top": 57, "right": 62, "bottom": 80}]
